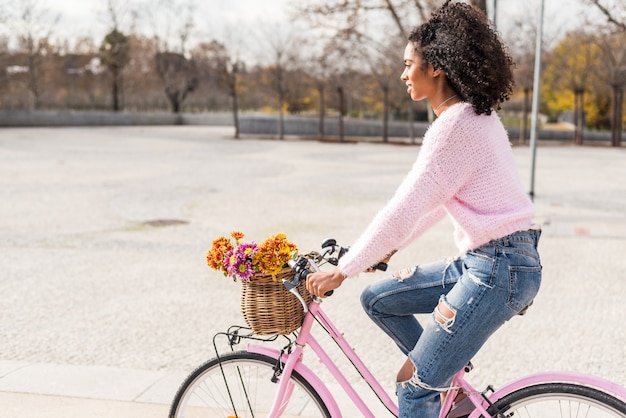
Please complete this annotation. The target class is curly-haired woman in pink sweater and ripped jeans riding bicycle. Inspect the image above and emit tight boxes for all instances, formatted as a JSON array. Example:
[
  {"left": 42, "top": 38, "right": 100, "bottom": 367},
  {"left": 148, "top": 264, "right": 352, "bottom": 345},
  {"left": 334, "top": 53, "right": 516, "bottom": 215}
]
[{"left": 307, "top": 0, "right": 541, "bottom": 417}]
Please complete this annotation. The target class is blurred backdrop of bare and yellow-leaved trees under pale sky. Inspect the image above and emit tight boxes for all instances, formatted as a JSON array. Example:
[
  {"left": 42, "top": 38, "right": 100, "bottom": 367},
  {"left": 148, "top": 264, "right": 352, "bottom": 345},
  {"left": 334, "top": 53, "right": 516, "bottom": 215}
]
[{"left": 0, "top": 0, "right": 626, "bottom": 146}]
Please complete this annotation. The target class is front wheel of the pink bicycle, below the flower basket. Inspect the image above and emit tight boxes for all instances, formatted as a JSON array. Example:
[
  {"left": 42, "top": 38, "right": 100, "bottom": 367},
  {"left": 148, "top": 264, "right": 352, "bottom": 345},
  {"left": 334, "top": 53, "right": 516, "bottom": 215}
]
[{"left": 169, "top": 351, "right": 330, "bottom": 418}]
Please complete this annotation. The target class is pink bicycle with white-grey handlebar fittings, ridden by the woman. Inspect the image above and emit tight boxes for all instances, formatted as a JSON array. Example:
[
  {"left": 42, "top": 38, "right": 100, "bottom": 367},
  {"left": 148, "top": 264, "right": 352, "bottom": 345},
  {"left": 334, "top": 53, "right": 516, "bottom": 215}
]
[{"left": 169, "top": 240, "right": 626, "bottom": 418}]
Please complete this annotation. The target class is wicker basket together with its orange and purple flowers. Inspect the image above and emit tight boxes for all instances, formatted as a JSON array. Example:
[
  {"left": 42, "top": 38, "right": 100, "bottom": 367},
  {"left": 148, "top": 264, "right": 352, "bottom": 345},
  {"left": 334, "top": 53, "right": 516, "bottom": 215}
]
[{"left": 206, "top": 231, "right": 311, "bottom": 335}]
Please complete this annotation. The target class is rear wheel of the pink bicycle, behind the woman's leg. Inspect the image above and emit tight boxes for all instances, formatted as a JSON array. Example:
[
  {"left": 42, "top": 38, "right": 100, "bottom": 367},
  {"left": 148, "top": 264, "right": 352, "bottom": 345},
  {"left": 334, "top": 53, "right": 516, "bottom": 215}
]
[{"left": 487, "top": 383, "right": 626, "bottom": 418}]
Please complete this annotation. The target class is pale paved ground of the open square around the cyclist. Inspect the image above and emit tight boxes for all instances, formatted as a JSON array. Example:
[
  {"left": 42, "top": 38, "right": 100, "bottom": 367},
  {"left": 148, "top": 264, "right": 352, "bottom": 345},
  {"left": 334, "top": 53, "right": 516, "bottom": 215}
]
[{"left": 0, "top": 126, "right": 626, "bottom": 418}]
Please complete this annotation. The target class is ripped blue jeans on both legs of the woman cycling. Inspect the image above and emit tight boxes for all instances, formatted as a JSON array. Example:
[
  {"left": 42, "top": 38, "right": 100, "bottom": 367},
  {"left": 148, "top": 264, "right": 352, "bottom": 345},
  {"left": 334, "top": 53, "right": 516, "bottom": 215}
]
[{"left": 361, "top": 230, "right": 541, "bottom": 418}]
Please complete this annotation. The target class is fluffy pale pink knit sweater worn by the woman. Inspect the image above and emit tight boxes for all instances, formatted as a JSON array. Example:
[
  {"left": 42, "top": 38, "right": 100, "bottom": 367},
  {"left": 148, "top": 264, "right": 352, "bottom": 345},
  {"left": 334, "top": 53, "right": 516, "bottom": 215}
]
[{"left": 339, "top": 103, "right": 534, "bottom": 276}]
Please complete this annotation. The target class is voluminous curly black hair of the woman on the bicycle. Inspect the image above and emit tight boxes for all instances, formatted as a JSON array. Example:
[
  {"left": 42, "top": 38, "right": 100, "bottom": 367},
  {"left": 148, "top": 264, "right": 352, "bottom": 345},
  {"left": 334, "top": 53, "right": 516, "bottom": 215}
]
[{"left": 409, "top": 0, "right": 514, "bottom": 115}]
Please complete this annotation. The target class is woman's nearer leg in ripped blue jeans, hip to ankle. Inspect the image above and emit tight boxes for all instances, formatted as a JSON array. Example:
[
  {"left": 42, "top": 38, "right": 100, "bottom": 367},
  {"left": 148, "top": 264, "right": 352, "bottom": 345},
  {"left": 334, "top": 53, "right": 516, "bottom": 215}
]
[{"left": 397, "top": 231, "right": 541, "bottom": 418}]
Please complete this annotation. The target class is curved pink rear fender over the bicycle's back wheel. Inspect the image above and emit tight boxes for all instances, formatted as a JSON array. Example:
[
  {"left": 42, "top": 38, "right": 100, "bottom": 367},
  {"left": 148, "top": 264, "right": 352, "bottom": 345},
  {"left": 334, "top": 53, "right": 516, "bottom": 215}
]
[{"left": 468, "top": 372, "right": 626, "bottom": 418}]
